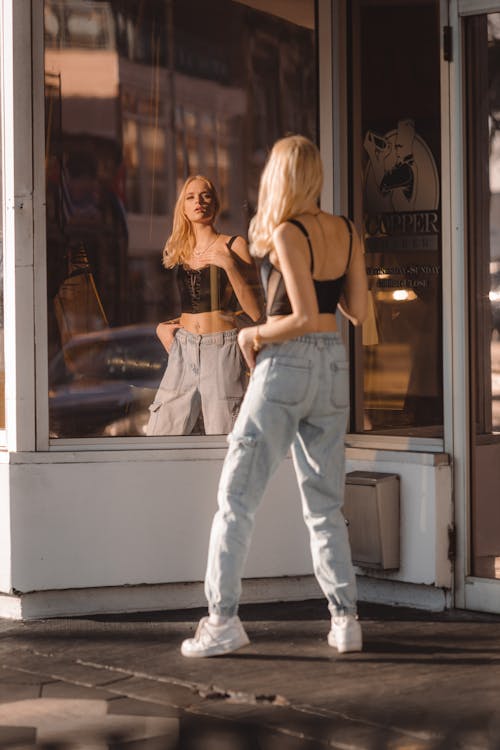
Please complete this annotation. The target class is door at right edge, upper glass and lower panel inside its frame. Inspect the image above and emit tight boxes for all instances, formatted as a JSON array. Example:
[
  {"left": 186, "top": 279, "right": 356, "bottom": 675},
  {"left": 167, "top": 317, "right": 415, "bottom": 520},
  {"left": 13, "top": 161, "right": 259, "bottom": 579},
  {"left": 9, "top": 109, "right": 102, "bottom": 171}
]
[{"left": 463, "top": 6, "right": 500, "bottom": 611}]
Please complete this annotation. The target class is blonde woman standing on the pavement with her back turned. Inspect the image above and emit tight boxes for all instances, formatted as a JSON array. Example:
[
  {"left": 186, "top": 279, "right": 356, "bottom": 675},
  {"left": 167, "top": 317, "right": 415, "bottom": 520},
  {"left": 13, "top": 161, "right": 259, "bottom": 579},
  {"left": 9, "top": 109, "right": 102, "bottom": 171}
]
[{"left": 181, "top": 136, "right": 368, "bottom": 657}]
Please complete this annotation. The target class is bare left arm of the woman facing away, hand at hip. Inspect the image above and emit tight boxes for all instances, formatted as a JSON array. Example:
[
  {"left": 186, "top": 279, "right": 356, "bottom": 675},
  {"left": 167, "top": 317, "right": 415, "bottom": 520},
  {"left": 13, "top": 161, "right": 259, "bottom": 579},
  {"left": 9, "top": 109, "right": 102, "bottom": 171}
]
[{"left": 238, "top": 223, "right": 319, "bottom": 368}]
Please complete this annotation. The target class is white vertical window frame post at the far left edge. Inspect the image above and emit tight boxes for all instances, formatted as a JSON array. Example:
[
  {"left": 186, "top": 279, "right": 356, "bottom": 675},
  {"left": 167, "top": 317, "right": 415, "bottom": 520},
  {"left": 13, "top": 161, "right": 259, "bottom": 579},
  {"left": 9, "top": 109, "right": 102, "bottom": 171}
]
[{"left": 1, "top": 0, "right": 36, "bottom": 452}]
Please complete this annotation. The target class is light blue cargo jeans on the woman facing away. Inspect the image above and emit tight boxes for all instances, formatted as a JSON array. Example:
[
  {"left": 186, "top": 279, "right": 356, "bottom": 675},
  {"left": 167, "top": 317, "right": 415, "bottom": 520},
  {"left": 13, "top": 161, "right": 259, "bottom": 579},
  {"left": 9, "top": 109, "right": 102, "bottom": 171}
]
[{"left": 205, "top": 333, "right": 356, "bottom": 616}]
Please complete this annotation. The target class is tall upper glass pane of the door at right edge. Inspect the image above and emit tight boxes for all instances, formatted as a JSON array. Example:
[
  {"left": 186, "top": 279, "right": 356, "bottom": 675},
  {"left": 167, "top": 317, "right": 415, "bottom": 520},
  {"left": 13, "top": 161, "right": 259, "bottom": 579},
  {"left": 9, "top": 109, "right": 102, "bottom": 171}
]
[{"left": 466, "top": 13, "right": 500, "bottom": 435}]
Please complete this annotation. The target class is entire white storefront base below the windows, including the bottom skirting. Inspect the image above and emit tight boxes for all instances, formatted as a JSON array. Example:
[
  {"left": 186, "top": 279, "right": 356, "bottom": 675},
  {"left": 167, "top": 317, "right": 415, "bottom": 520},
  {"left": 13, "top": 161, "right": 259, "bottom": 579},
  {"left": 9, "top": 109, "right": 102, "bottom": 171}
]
[{"left": 0, "top": 448, "right": 452, "bottom": 619}]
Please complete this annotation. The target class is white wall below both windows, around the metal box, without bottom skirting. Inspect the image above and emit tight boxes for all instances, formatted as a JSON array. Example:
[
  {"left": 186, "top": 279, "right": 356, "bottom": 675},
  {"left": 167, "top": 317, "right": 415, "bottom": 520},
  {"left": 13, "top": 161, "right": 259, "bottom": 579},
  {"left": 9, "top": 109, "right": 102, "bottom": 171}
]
[{"left": 1, "top": 449, "right": 451, "bottom": 604}]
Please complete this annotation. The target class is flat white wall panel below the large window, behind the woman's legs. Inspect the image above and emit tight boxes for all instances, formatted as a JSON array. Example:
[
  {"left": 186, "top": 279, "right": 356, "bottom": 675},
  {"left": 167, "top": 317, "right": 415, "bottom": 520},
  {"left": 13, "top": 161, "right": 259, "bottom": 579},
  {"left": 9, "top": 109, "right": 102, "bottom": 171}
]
[{"left": 11, "top": 454, "right": 311, "bottom": 591}]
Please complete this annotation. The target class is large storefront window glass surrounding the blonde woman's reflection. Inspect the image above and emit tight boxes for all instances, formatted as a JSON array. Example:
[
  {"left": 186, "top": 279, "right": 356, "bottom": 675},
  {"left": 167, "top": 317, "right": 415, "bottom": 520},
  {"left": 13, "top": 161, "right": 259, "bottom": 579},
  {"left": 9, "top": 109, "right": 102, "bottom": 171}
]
[{"left": 44, "top": 0, "right": 317, "bottom": 438}]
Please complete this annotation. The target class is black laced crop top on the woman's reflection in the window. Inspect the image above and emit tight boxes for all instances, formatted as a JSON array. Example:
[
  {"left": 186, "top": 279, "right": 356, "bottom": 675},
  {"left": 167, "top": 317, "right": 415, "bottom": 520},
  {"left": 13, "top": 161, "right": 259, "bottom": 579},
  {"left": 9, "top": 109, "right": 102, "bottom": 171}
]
[{"left": 177, "top": 235, "right": 239, "bottom": 313}]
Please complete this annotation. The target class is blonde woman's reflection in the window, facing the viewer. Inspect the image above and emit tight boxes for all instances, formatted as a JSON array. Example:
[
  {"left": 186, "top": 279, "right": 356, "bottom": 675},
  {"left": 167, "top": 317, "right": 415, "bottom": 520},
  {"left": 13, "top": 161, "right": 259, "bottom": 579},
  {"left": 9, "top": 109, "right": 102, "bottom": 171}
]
[{"left": 146, "top": 176, "right": 259, "bottom": 435}]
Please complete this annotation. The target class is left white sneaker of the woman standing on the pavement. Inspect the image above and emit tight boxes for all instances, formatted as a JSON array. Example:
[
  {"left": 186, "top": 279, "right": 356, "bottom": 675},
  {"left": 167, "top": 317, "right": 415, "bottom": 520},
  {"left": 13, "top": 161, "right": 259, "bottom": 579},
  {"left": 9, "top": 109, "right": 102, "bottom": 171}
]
[{"left": 181, "top": 615, "right": 250, "bottom": 659}]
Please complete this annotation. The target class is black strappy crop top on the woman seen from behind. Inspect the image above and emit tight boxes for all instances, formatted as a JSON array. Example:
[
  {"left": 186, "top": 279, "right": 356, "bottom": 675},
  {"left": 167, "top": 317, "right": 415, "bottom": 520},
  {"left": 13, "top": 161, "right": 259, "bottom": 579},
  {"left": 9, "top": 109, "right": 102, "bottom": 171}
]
[{"left": 261, "top": 216, "right": 352, "bottom": 315}]
